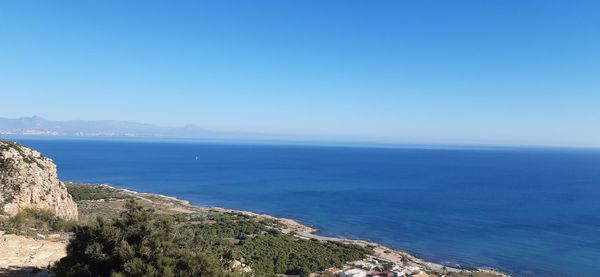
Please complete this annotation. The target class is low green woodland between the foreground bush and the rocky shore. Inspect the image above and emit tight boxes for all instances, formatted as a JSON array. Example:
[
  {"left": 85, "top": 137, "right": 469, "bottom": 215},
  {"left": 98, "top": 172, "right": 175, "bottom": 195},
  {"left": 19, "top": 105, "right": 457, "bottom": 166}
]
[{"left": 185, "top": 213, "right": 370, "bottom": 276}]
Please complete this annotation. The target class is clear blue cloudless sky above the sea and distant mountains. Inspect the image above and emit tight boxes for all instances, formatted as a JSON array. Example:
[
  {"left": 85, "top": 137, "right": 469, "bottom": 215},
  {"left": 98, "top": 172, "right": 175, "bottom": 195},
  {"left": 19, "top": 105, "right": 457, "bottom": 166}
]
[{"left": 0, "top": 0, "right": 600, "bottom": 146}]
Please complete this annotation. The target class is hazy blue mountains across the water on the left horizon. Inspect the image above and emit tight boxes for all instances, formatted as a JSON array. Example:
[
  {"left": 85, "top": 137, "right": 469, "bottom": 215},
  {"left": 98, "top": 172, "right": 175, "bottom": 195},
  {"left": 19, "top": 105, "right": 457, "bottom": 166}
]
[{"left": 0, "top": 116, "right": 220, "bottom": 138}]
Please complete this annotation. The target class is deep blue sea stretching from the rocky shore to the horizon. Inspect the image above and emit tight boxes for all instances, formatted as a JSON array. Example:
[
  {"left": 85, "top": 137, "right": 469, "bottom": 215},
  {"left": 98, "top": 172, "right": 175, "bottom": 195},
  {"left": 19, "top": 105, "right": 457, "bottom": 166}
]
[{"left": 11, "top": 139, "right": 600, "bottom": 276}]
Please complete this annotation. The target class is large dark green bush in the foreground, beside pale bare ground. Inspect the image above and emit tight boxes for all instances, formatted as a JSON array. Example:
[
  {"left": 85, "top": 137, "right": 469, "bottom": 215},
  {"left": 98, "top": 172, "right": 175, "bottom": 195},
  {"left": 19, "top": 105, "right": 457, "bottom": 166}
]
[{"left": 55, "top": 201, "right": 230, "bottom": 276}]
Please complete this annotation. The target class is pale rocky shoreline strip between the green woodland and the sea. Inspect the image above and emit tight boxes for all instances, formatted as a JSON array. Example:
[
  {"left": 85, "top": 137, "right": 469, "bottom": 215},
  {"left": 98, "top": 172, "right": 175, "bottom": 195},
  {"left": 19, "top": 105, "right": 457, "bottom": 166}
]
[{"left": 97, "top": 184, "right": 511, "bottom": 277}]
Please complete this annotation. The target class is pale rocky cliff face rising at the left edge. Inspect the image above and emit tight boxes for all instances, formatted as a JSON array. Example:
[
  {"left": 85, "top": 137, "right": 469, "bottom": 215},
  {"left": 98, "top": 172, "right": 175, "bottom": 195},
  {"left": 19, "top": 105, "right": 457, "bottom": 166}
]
[{"left": 0, "top": 141, "right": 77, "bottom": 220}]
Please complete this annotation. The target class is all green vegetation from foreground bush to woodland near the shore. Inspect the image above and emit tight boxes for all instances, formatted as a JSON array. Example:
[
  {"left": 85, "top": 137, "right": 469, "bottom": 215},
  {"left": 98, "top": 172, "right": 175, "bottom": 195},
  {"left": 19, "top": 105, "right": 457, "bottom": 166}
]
[{"left": 56, "top": 200, "right": 369, "bottom": 276}]
